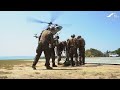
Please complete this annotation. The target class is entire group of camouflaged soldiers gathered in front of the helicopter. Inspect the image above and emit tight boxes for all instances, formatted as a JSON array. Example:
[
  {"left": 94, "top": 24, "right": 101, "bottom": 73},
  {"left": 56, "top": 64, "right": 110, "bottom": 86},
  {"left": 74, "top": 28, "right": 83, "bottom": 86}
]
[{"left": 32, "top": 27, "right": 85, "bottom": 70}]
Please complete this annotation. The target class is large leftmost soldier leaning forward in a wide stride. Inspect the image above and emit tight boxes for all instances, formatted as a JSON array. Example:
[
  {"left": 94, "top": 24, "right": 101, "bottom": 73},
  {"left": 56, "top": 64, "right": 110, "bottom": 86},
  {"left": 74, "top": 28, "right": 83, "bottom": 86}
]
[{"left": 32, "top": 28, "right": 54, "bottom": 70}]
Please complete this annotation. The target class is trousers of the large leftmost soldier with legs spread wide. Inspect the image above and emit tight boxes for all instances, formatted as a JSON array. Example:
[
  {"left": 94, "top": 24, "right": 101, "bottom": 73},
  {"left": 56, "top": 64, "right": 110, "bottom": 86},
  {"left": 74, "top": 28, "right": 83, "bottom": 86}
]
[{"left": 33, "top": 43, "right": 50, "bottom": 66}]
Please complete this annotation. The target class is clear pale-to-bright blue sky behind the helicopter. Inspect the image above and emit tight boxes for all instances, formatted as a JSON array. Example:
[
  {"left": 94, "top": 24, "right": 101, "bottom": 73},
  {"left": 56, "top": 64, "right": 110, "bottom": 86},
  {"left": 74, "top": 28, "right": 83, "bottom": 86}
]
[{"left": 0, "top": 11, "right": 120, "bottom": 56}]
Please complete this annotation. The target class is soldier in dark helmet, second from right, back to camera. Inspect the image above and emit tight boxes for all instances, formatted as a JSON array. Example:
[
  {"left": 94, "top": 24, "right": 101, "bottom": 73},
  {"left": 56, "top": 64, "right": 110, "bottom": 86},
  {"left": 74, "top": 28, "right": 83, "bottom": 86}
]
[{"left": 67, "top": 34, "right": 78, "bottom": 66}]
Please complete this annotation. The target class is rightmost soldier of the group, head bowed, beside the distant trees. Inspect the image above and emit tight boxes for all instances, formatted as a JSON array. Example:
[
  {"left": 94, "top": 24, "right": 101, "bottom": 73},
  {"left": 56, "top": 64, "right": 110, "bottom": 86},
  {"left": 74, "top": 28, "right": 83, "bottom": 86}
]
[{"left": 77, "top": 36, "right": 85, "bottom": 65}]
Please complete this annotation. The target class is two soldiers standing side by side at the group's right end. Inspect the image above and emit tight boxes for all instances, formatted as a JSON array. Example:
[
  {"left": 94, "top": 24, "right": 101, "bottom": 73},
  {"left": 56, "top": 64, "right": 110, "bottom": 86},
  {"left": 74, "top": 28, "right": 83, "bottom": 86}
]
[{"left": 64, "top": 34, "right": 85, "bottom": 66}]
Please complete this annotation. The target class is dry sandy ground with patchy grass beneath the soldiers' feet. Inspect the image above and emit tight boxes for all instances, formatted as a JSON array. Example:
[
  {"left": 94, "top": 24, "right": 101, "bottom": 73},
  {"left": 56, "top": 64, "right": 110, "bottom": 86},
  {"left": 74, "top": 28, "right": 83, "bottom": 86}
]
[{"left": 0, "top": 60, "right": 120, "bottom": 79}]
